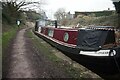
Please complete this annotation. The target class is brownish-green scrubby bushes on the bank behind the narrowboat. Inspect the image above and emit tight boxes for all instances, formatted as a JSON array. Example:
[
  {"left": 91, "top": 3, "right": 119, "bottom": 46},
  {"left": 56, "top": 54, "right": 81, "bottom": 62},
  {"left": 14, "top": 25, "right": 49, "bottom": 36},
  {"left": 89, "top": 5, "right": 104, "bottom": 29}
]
[{"left": 71, "top": 14, "right": 118, "bottom": 27}]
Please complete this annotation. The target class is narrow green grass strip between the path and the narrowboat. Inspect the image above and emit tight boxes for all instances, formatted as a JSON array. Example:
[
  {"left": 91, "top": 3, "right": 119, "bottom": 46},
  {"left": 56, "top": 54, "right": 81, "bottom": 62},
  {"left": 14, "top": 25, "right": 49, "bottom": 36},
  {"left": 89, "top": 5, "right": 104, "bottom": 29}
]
[{"left": 27, "top": 30, "right": 61, "bottom": 62}]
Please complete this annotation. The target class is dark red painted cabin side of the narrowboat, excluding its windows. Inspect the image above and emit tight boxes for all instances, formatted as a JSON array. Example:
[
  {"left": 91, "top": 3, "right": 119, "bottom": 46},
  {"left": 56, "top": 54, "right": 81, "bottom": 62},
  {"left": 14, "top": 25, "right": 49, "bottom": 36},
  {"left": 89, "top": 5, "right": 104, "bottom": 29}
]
[{"left": 41, "top": 27, "right": 78, "bottom": 45}]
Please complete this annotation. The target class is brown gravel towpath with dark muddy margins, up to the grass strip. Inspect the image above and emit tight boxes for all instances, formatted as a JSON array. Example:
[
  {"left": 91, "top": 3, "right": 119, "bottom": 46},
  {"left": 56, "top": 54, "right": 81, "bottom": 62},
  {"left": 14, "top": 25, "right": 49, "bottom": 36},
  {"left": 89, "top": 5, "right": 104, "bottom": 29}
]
[{"left": 3, "top": 28, "right": 69, "bottom": 78}]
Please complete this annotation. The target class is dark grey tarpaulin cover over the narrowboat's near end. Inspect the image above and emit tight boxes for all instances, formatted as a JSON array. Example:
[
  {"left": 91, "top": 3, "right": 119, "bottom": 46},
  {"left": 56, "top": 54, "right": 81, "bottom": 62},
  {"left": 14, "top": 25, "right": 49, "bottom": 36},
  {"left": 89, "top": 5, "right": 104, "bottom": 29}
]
[{"left": 77, "top": 29, "right": 115, "bottom": 50}]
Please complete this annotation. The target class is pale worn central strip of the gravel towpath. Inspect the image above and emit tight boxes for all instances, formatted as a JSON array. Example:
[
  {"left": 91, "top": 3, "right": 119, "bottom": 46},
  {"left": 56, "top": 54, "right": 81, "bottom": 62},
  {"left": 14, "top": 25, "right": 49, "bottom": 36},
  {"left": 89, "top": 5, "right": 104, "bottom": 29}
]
[{"left": 8, "top": 29, "right": 34, "bottom": 78}]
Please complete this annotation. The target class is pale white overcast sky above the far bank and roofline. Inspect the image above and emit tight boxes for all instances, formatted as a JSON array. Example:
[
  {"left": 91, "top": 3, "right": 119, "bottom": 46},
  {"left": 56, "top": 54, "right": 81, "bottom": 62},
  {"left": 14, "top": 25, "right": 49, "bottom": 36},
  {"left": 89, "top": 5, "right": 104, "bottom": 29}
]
[{"left": 39, "top": 0, "right": 115, "bottom": 19}]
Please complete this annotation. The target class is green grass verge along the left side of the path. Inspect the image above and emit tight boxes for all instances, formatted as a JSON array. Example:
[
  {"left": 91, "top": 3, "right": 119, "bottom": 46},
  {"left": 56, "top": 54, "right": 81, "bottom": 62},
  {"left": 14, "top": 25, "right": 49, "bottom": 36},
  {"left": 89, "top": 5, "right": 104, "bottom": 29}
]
[{"left": 0, "top": 25, "right": 18, "bottom": 79}]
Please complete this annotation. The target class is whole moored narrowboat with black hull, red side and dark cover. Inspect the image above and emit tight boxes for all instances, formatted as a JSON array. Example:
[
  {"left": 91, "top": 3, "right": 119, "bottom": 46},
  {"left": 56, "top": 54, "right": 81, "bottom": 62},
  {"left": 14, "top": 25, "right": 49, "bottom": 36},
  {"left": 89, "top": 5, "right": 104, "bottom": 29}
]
[{"left": 34, "top": 0, "right": 120, "bottom": 73}]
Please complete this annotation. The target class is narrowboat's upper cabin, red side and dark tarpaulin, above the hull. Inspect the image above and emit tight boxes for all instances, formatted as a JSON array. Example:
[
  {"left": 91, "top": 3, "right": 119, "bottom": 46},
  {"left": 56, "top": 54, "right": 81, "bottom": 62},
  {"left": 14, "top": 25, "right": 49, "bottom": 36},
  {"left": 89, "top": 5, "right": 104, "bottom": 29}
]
[{"left": 36, "top": 21, "right": 116, "bottom": 50}]
